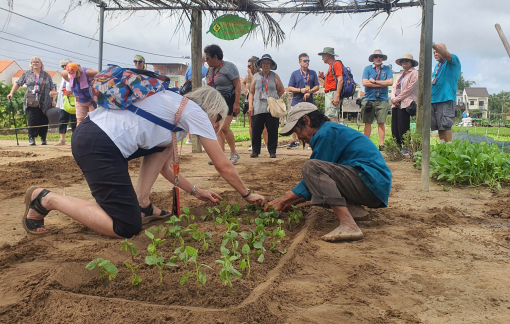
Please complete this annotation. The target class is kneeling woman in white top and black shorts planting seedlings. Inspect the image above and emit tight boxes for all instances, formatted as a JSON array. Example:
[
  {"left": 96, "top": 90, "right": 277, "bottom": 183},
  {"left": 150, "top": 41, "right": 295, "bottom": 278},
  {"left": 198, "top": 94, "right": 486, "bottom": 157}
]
[{"left": 22, "top": 87, "right": 265, "bottom": 238}]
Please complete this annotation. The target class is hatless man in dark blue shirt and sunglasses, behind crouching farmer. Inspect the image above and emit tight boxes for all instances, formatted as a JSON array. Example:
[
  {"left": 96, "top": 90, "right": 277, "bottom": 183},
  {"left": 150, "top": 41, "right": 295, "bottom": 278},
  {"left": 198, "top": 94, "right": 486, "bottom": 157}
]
[{"left": 288, "top": 53, "right": 319, "bottom": 150}]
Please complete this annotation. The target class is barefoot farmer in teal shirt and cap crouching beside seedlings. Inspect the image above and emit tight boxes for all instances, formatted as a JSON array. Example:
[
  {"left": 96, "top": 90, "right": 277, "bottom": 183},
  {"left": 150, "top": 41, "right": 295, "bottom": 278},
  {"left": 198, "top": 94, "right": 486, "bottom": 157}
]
[{"left": 266, "top": 102, "right": 391, "bottom": 241}]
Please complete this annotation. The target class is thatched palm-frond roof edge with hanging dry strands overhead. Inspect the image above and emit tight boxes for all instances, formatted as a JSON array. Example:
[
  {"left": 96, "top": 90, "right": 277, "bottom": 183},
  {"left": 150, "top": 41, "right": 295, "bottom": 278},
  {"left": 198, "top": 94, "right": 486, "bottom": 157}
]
[{"left": 86, "top": 0, "right": 424, "bottom": 46}]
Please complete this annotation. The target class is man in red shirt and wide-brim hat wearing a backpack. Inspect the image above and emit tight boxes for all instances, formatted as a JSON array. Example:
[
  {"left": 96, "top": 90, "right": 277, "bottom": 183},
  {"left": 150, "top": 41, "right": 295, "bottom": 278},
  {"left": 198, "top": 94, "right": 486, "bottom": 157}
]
[{"left": 319, "top": 47, "right": 344, "bottom": 122}]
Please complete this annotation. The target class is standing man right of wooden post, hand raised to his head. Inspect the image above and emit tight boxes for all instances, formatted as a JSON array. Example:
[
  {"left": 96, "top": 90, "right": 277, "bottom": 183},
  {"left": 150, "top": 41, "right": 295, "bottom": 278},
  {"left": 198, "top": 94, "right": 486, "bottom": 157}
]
[{"left": 430, "top": 44, "right": 461, "bottom": 142}]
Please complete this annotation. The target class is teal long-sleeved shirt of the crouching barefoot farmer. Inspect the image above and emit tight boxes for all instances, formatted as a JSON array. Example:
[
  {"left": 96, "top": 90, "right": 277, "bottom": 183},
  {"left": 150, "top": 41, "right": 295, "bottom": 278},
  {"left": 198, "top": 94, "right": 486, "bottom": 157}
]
[{"left": 292, "top": 122, "right": 391, "bottom": 207}]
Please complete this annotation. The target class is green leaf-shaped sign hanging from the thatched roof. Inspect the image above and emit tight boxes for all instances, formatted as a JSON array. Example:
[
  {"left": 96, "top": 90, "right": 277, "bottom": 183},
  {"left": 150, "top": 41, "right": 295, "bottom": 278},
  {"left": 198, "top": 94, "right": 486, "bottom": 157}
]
[{"left": 208, "top": 15, "right": 258, "bottom": 40}]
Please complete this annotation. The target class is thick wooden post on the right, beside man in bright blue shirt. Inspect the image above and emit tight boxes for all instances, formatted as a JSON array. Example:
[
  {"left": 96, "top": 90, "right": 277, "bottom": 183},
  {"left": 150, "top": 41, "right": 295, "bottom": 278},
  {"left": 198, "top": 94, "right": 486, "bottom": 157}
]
[{"left": 420, "top": 0, "right": 434, "bottom": 191}]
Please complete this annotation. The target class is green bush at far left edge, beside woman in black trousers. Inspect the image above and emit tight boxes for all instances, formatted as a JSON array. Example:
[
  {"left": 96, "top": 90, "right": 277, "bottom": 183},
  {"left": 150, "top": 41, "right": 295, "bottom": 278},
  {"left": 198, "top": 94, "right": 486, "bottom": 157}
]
[{"left": 0, "top": 81, "right": 26, "bottom": 128}]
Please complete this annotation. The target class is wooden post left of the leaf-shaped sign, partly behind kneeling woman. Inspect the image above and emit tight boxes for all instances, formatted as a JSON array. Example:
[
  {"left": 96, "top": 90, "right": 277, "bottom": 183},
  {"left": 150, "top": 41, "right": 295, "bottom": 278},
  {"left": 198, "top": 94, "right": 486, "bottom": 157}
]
[{"left": 191, "top": 9, "right": 202, "bottom": 153}]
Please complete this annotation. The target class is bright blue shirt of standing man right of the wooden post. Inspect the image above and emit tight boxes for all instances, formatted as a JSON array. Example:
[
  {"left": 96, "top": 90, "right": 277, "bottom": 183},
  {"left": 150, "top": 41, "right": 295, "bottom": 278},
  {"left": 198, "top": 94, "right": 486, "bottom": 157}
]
[{"left": 432, "top": 54, "right": 461, "bottom": 103}]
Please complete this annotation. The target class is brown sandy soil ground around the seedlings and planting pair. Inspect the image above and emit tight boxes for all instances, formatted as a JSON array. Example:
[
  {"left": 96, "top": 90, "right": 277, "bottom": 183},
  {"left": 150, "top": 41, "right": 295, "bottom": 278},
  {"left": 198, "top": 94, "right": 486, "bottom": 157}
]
[{"left": 0, "top": 141, "right": 510, "bottom": 323}]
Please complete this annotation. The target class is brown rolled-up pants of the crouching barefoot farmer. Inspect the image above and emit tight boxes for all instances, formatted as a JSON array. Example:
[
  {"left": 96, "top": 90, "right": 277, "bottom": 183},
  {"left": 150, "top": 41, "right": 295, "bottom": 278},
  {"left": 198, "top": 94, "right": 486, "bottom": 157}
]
[{"left": 302, "top": 160, "right": 383, "bottom": 208}]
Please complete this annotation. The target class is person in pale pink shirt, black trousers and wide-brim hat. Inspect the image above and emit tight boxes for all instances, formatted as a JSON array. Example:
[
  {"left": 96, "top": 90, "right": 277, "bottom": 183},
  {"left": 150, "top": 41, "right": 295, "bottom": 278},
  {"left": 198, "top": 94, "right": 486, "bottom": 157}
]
[{"left": 390, "top": 54, "right": 418, "bottom": 155}]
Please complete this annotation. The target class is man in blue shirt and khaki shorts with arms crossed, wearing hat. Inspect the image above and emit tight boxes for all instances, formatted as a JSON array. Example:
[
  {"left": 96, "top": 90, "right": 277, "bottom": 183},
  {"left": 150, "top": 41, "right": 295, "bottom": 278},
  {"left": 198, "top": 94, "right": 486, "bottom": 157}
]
[{"left": 361, "top": 50, "right": 393, "bottom": 151}]
